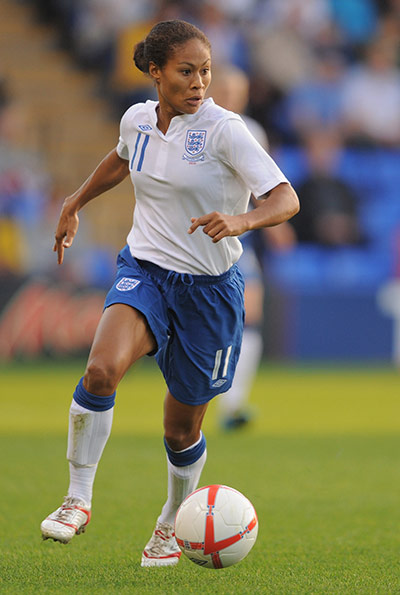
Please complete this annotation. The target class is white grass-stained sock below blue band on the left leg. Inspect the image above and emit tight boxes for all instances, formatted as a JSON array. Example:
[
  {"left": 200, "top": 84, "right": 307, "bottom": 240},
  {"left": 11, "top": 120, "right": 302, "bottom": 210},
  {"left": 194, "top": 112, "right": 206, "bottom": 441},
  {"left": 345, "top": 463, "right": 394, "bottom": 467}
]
[{"left": 67, "top": 400, "right": 114, "bottom": 506}]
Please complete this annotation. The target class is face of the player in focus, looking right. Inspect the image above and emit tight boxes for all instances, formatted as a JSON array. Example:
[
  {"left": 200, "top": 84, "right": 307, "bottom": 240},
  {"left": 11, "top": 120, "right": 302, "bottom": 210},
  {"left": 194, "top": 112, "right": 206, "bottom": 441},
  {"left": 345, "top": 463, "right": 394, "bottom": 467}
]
[{"left": 150, "top": 39, "right": 211, "bottom": 118}]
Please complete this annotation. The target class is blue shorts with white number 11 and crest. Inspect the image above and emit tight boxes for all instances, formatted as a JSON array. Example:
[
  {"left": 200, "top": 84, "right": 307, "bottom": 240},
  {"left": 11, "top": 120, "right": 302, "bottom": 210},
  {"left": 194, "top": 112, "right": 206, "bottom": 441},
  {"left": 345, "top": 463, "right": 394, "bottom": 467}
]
[{"left": 105, "top": 246, "right": 244, "bottom": 405}]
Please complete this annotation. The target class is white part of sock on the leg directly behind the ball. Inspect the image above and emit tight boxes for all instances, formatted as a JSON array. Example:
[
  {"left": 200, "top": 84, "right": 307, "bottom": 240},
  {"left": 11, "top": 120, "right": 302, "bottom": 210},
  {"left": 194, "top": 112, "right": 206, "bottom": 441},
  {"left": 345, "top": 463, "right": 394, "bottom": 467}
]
[{"left": 158, "top": 450, "right": 207, "bottom": 525}]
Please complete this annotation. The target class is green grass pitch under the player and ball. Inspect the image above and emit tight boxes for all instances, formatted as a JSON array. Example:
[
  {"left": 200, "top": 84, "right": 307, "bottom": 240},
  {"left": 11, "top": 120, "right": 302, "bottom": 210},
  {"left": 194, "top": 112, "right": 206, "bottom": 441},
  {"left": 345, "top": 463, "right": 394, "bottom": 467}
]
[{"left": 0, "top": 362, "right": 400, "bottom": 595}]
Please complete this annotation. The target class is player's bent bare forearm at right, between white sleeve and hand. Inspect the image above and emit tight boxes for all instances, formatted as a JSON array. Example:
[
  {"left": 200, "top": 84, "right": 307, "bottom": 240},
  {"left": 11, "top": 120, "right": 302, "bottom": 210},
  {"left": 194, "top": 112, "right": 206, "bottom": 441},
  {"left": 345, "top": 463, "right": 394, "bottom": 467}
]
[{"left": 245, "top": 184, "right": 300, "bottom": 230}]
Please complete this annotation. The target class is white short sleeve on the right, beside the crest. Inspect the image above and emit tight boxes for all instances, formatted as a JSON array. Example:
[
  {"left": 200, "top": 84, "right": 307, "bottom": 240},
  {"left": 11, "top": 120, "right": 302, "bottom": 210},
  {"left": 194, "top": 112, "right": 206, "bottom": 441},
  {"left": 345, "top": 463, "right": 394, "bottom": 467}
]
[{"left": 215, "top": 116, "right": 288, "bottom": 198}]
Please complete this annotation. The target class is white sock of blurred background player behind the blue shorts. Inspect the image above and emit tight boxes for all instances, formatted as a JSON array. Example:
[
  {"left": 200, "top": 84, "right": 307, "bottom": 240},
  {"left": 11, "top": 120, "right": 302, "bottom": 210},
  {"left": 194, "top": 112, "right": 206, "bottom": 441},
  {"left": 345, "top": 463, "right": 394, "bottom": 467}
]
[{"left": 218, "top": 327, "right": 263, "bottom": 416}]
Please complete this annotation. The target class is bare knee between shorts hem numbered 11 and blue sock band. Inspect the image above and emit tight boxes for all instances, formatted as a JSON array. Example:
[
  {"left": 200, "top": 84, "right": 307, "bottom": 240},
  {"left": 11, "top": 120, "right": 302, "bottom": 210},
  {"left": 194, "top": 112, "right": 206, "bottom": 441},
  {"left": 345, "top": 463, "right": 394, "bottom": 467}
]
[{"left": 164, "top": 391, "right": 208, "bottom": 451}]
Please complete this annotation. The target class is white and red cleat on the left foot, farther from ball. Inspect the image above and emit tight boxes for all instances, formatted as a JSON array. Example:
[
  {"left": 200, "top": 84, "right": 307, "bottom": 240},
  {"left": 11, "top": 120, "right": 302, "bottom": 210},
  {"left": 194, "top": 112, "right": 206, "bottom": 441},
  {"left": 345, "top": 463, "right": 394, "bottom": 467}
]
[{"left": 40, "top": 496, "right": 91, "bottom": 543}]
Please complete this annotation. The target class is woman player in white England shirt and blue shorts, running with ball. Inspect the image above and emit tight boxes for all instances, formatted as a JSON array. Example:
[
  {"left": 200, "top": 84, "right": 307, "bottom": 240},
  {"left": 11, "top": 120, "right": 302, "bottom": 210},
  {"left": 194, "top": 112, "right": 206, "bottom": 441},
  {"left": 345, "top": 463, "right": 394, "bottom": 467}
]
[{"left": 41, "top": 20, "right": 299, "bottom": 566}]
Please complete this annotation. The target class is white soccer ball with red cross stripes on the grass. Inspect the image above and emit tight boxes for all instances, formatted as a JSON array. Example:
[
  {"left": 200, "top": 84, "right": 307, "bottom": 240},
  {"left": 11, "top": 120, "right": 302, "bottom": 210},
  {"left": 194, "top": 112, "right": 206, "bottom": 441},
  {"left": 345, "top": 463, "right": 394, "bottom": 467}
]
[{"left": 175, "top": 485, "right": 258, "bottom": 568}]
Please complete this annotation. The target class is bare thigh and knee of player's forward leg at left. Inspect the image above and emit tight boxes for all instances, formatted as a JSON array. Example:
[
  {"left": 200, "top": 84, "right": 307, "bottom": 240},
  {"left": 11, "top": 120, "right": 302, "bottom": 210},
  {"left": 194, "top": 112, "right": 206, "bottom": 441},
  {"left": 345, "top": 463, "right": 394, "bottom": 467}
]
[{"left": 86, "top": 304, "right": 156, "bottom": 391}]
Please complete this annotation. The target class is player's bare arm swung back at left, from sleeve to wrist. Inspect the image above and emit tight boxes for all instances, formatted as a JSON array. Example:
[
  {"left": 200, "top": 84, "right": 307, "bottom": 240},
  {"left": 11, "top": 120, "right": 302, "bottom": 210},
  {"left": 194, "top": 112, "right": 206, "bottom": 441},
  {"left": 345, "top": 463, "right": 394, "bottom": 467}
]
[{"left": 65, "top": 149, "right": 129, "bottom": 212}]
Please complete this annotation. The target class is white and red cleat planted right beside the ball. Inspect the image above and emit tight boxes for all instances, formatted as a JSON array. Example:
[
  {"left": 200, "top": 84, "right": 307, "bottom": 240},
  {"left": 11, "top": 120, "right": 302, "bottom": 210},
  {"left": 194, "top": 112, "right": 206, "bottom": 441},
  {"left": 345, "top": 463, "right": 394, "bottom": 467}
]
[{"left": 141, "top": 522, "right": 182, "bottom": 566}]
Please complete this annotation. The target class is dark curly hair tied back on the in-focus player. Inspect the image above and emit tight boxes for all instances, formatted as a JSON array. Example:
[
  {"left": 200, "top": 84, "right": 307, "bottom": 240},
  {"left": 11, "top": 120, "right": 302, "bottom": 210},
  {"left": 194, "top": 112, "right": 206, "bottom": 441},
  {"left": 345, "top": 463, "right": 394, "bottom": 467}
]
[{"left": 133, "top": 20, "right": 211, "bottom": 74}]
